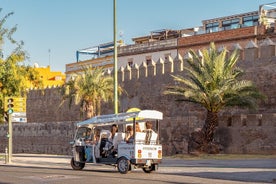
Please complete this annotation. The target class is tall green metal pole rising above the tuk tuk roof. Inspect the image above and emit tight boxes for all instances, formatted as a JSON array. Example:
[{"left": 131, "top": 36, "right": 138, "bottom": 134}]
[{"left": 113, "top": 0, "right": 118, "bottom": 114}]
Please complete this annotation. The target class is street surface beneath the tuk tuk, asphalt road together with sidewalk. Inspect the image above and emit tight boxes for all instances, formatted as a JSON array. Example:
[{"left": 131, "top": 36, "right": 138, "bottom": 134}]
[{"left": 0, "top": 155, "right": 276, "bottom": 184}]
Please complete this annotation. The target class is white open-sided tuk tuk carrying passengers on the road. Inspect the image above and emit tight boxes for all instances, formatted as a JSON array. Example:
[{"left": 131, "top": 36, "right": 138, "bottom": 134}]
[{"left": 71, "top": 110, "right": 163, "bottom": 174}]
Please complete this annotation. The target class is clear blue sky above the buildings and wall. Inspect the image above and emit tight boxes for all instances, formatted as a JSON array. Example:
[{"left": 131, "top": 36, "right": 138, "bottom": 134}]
[{"left": 0, "top": 0, "right": 273, "bottom": 72}]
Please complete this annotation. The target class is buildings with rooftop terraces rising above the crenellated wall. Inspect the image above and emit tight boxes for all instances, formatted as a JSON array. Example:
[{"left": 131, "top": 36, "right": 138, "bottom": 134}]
[{"left": 66, "top": 4, "right": 276, "bottom": 80}]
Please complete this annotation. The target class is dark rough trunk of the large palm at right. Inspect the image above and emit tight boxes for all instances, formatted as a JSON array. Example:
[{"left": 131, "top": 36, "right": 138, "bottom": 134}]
[{"left": 202, "top": 111, "right": 218, "bottom": 144}]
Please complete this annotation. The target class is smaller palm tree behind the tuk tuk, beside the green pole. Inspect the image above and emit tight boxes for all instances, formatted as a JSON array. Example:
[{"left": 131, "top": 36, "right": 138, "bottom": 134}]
[{"left": 62, "top": 67, "right": 118, "bottom": 119}]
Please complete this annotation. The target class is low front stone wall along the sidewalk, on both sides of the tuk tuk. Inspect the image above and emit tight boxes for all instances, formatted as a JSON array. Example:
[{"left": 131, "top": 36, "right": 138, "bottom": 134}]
[{"left": 0, "top": 113, "right": 276, "bottom": 155}]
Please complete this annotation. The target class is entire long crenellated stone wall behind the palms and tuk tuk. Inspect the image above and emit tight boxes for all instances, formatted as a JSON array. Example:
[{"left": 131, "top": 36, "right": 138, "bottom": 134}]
[{"left": 0, "top": 40, "right": 276, "bottom": 155}]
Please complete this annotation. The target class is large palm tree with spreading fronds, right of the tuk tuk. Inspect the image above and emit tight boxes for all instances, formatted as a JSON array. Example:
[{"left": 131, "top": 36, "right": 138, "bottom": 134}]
[{"left": 164, "top": 43, "right": 264, "bottom": 152}]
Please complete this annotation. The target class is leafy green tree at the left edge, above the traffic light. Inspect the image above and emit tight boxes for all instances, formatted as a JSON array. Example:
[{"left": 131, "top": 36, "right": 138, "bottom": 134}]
[{"left": 0, "top": 9, "right": 42, "bottom": 121}]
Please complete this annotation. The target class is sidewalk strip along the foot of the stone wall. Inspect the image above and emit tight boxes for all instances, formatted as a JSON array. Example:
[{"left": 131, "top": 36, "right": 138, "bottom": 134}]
[{"left": 0, "top": 154, "right": 276, "bottom": 169}]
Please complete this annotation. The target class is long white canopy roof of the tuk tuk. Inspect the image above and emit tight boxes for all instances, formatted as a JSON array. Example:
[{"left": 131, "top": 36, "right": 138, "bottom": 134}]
[{"left": 77, "top": 110, "right": 163, "bottom": 127}]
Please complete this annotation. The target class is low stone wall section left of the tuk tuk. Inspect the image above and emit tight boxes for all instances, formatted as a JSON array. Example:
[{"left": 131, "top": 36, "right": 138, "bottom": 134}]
[{"left": 0, "top": 122, "right": 75, "bottom": 155}]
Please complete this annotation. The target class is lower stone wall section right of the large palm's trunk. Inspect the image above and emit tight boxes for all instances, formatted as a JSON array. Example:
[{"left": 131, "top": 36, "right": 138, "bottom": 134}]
[{"left": 215, "top": 113, "right": 276, "bottom": 154}]
